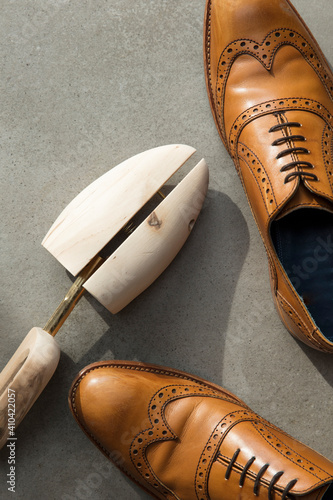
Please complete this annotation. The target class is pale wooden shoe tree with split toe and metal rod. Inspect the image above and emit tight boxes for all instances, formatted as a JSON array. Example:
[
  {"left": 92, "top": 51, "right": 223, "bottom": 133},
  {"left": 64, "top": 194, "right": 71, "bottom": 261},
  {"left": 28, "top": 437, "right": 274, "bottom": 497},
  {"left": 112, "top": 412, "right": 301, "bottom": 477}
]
[{"left": 0, "top": 144, "right": 208, "bottom": 448}]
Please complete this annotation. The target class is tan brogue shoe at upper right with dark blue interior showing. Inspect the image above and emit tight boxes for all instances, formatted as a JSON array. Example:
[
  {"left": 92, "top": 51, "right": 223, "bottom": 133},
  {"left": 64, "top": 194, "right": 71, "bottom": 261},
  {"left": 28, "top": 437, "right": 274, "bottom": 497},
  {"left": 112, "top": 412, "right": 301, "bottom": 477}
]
[{"left": 204, "top": 0, "right": 333, "bottom": 352}]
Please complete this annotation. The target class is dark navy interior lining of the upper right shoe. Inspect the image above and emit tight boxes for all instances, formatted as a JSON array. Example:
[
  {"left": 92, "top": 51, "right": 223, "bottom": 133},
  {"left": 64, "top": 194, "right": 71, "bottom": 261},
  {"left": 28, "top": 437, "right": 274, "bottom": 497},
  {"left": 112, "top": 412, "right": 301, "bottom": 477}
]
[{"left": 271, "top": 208, "right": 333, "bottom": 342}]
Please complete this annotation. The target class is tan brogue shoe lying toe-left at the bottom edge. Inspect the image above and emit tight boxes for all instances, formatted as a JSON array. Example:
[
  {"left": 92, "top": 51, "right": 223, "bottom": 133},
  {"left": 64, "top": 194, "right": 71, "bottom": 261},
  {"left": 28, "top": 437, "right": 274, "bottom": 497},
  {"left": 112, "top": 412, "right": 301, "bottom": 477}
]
[{"left": 69, "top": 361, "right": 333, "bottom": 500}]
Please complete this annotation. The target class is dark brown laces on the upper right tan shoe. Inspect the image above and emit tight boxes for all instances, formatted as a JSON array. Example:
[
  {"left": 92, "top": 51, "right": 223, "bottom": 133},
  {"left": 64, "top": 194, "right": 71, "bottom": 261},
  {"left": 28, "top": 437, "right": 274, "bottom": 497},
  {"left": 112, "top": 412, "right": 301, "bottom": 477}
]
[{"left": 268, "top": 121, "right": 318, "bottom": 184}]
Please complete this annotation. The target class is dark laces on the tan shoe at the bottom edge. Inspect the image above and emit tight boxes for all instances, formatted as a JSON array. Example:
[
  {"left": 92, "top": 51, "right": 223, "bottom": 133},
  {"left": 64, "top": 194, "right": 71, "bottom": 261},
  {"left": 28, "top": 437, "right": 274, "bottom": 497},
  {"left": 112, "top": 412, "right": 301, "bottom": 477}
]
[{"left": 225, "top": 448, "right": 297, "bottom": 500}]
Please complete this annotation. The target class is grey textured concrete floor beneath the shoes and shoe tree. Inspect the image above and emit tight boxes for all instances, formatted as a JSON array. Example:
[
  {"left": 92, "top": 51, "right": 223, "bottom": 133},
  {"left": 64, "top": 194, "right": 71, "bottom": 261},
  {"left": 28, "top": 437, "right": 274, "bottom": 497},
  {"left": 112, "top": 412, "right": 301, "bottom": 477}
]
[{"left": 0, "top": 0, "right": 333, "bottom": 500}]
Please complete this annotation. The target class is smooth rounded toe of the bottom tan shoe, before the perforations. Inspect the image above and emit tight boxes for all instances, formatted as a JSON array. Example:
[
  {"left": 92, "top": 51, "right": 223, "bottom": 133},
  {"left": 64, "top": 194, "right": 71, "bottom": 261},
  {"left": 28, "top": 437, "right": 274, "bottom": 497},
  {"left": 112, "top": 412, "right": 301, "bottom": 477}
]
[{"left": 69, "top": 366, "right": 151, "bottom": 465}]
